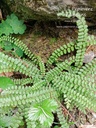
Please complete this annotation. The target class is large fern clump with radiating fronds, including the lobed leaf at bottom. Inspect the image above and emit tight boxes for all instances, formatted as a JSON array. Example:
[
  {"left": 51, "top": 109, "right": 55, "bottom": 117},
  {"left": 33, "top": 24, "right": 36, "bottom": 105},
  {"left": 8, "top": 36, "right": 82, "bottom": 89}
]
[{"left": 0, "top": 10, "right": 96, "bottom": 128}]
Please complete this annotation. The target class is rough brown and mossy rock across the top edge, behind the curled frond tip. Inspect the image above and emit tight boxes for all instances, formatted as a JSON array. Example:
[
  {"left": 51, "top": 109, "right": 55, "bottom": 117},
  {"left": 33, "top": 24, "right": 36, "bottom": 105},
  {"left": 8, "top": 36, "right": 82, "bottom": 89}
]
[{"left": 0, "top": 0, "right": 96, "bottom": 22}]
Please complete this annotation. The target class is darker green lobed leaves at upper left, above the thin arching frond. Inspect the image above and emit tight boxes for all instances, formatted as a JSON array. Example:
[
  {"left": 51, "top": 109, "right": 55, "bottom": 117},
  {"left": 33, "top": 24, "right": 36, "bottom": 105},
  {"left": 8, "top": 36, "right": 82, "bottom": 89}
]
[{"left": 0, "top": 14, "right": 26, "bottom": 36}]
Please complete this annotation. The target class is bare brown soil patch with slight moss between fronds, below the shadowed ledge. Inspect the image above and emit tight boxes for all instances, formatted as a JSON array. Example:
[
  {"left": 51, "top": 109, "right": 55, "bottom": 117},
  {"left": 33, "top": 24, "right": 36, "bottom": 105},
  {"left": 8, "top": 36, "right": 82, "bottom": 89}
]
[{"left": 20, "top": 22, "right": 77, "bottom": 62}]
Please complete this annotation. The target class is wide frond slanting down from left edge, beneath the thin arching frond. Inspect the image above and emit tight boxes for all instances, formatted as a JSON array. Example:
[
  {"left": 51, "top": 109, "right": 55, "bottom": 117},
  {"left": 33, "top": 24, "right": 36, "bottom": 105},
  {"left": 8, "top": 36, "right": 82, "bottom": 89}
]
[{"left": 0, "top": 52, "right": 40, "bottom": 77}]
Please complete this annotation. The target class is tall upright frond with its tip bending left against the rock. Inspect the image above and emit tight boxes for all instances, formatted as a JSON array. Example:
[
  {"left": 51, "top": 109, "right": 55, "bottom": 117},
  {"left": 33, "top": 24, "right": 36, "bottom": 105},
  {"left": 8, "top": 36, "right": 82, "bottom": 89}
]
[{"left": 58, "top": 10, "right": 88, "bottom": 67}]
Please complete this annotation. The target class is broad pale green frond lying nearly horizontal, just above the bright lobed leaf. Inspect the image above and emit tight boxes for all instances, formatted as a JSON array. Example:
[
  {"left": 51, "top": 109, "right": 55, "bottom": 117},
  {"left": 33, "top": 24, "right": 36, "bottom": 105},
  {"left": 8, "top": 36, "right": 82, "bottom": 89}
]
[{"left": 0, "top": 86, "right": 56, "bottom": 108}]
